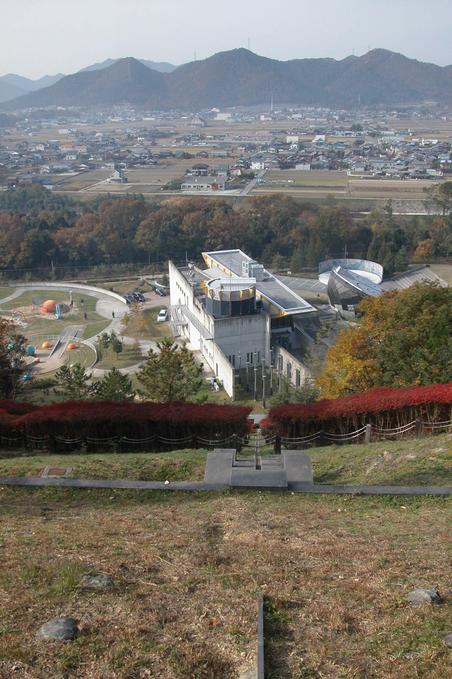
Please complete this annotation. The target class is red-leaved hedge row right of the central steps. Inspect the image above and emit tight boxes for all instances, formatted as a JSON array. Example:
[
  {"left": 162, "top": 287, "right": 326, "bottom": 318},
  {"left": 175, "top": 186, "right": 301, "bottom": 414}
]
[{"left": 267, "top": 383, "right": 452, "bottom": 437}]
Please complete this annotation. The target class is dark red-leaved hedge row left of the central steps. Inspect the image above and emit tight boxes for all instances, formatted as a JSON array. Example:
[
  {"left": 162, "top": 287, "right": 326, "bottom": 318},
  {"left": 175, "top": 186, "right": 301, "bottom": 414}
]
[{"left": 0, "top": 401, "right": 251, "bottom": 439}]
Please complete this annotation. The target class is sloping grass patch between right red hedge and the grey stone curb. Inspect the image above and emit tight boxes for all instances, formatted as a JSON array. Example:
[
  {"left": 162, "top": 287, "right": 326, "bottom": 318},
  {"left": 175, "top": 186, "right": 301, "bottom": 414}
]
[{"left": 307, "top": 434, "right": 452, "bottom": 486}]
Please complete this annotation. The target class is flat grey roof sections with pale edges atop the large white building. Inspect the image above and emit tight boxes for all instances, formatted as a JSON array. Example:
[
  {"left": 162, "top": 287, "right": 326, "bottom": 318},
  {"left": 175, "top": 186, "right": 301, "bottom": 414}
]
[{"left": 203, "top": 250, "right": 316, "bottom": 315}]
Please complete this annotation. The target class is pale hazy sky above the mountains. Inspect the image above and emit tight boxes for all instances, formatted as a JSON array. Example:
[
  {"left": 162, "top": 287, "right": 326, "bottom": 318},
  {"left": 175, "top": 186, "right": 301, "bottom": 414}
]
[{"left": 0, "top": 0, "right": 452, "bottom": 78}]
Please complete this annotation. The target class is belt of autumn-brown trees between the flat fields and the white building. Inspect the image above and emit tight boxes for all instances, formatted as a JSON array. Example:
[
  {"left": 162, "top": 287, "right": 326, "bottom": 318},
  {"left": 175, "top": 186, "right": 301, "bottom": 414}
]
[{"left": 0, "top": 187, "right": 452, "bottom": 274}]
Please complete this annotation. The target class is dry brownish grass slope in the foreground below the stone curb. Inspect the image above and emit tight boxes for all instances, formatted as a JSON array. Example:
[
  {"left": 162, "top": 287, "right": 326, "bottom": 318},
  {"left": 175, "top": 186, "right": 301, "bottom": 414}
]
[{"left": 0, "top": 488, "right": 452, "bottom": 679}]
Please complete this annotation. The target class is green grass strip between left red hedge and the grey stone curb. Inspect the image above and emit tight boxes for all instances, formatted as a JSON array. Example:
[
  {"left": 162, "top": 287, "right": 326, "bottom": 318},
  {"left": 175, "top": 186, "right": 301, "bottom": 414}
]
[{"left": 0, "top": 450, "right": 206, "bottom": 481}]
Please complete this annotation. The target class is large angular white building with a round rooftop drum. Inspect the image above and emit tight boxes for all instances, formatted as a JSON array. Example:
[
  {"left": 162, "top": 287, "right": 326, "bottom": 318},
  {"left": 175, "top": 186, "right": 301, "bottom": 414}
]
[{"left": 169, "top": 250, "right": 317, "bottom": 398}]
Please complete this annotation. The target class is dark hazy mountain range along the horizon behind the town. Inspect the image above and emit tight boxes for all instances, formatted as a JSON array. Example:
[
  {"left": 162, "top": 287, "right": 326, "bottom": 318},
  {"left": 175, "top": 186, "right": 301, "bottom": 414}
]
[{"left": 2, "top": 49, "right": 452, "bottom": 111}]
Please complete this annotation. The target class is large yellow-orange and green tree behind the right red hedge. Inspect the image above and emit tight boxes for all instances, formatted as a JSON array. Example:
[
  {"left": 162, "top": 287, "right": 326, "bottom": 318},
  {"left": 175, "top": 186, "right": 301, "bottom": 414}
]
[{"left": 317, "top": 284, "right": 452, "bottom": 398}]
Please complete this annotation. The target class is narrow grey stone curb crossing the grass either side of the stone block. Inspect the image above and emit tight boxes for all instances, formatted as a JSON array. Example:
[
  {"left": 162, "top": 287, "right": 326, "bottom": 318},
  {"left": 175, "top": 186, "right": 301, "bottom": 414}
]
[{"left": 0, "top": 476, "right": 452, "bottom": 497}]
